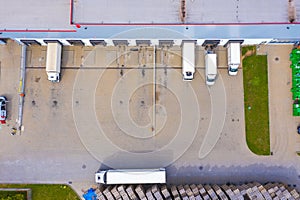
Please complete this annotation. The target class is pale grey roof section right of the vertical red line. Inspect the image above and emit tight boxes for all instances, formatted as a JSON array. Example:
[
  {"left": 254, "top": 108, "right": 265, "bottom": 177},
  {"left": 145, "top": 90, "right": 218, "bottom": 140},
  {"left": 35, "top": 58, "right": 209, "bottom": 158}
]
[{"left": 73, "top": 0, "right": 300, "bottom": 24}]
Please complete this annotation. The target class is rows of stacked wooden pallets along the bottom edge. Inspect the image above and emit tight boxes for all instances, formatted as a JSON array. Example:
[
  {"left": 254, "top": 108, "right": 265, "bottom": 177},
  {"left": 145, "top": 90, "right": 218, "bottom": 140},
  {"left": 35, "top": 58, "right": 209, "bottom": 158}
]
[{"left": 97, "top": 182, "right": 300, "bottom": 200}]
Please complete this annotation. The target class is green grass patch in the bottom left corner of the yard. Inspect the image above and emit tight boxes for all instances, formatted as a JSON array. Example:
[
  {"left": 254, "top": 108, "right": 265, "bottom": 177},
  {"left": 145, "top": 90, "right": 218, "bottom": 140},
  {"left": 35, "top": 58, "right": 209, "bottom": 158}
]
[{"left": 0, "top": 184, "right": 79, "bottom": 200}]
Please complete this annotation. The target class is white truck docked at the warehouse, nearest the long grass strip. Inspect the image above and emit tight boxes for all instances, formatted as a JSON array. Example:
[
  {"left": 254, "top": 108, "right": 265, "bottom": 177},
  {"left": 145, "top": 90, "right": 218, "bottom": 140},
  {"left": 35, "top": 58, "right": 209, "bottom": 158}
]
[{"left": 227, "top": 42, "right": 241, "bottom": 76}]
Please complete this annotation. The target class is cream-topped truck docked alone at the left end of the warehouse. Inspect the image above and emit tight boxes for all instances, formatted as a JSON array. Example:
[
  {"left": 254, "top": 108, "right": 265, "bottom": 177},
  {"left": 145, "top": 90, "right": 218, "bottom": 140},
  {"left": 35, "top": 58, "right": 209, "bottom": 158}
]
[{"left": 46, "top": 42, "right": 62, "bottom": 82}]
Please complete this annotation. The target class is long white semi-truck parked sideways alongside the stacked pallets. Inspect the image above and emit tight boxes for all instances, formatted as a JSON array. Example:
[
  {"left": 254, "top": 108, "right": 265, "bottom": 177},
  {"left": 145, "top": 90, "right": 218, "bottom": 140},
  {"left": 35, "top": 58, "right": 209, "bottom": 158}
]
[{"left": 95, "top": 168, "right": 166, "bottom": 184}]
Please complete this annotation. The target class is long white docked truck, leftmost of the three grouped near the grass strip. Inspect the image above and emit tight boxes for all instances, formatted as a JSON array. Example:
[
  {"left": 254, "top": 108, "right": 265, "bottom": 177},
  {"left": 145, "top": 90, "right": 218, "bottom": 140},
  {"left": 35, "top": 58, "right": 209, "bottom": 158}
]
[{"left": 182, "top": 41, "right": 195, "bottom": 81}]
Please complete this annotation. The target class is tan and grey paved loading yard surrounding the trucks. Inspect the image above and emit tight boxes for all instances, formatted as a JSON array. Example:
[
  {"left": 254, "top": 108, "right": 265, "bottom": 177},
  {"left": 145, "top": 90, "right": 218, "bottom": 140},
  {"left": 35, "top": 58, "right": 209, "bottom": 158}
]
[{"left": 0, "top": 43, "right": 300, "bottom": 197}]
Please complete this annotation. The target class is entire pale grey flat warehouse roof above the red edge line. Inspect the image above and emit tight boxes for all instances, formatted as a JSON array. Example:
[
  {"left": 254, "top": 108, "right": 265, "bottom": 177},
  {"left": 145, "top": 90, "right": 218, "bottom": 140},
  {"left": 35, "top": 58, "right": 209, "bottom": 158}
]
[{"left": 0, "top": 0, "right": 300, "bottom": 31}]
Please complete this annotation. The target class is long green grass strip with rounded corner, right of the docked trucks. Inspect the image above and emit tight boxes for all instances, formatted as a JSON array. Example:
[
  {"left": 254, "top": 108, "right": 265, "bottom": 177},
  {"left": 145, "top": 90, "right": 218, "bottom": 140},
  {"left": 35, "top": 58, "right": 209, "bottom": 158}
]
[{"left": 242, "top": 47, "right": 270, "bottom": 155}]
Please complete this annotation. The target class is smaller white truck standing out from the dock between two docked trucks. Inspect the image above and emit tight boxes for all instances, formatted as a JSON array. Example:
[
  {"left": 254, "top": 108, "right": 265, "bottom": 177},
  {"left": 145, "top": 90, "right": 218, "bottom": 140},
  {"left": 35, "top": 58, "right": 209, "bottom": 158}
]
[{"left": 205, "top": 51, "right": 217, "bottom": 85}]
